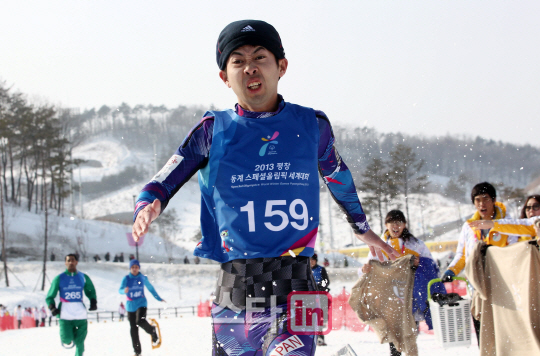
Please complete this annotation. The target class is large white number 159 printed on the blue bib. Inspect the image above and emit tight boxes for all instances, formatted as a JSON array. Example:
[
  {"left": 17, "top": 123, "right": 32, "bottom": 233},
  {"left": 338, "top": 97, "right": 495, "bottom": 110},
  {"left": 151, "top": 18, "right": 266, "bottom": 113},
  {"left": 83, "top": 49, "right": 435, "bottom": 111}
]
[{"left": 240, "top": 199, "right": 309, "bottom": 232}]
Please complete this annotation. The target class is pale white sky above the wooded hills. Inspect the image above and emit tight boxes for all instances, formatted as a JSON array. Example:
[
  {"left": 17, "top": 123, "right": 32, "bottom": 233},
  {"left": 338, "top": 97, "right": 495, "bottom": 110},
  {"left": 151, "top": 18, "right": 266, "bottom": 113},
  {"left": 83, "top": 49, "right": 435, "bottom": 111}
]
[{"left": 0, "top": 0, "right": 540, "bottom": 147}]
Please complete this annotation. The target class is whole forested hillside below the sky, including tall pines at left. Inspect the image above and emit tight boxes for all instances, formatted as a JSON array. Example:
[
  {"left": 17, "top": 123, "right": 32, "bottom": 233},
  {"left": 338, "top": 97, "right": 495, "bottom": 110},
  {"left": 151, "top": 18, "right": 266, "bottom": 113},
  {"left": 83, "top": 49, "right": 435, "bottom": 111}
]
[{"left": 0, "top": 79, "right": 540, "bottom": 220}]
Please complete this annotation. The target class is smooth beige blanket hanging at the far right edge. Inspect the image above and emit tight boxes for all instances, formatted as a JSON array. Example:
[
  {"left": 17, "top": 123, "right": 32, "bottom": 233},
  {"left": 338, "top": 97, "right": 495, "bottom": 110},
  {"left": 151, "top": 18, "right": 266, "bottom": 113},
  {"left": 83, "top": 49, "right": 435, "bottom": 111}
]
[{"left": 465, "top": 241, "right": 540, "bottom": 356}]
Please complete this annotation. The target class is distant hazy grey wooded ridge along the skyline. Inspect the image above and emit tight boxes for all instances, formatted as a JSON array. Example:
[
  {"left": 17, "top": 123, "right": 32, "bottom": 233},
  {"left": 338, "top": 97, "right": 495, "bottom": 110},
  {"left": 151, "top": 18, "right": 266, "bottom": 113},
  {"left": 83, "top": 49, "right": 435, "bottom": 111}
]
[{"left": 78, "top": 103, "right": 540, "bottom": 187}]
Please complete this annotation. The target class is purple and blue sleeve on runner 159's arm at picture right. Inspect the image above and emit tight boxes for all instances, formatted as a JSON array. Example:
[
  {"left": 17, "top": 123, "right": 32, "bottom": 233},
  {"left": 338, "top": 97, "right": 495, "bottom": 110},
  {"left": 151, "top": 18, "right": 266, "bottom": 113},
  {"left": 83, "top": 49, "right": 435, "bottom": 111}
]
[{"left": 316, "top": 111, "right": 370, "bottom": 234}]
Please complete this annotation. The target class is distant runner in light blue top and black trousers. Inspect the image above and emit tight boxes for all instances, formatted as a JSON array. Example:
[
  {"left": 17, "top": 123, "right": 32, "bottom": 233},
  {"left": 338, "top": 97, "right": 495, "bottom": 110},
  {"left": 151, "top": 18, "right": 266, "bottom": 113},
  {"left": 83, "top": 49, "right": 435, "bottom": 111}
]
[{"left": 119, "top": 259, "right": 165, "bottom": 356}]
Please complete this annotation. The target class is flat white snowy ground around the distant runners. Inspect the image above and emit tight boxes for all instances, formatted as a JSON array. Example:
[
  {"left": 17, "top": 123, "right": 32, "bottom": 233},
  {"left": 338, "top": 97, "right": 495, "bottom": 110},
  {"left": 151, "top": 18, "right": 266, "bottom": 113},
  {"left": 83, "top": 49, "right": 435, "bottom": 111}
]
[{"left": 0, "top": 262, "right": 478, "bottom": 356}]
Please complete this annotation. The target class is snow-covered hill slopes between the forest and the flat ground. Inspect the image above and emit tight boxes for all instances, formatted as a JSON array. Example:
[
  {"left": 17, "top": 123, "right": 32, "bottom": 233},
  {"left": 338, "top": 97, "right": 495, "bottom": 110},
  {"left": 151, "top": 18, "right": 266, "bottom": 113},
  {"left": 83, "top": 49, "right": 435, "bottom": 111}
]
[{"left": 1, "top": 137, "right": 490, "bottom": 268}]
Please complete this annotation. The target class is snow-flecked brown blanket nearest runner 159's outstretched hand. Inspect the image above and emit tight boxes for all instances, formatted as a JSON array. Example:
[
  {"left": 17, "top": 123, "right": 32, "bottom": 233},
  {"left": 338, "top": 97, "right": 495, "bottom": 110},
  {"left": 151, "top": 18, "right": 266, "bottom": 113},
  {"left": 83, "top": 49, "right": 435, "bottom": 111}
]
[{"left": 349, "top": 255, "right": 418, "bottom": 356}]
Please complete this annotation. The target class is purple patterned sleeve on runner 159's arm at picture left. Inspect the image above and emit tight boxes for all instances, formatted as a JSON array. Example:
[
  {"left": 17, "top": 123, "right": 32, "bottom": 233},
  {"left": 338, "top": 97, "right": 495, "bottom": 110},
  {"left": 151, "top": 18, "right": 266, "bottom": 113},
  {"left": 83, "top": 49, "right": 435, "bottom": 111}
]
[{"left": 133, "top": 117, "right": 214, "bottom": 221}]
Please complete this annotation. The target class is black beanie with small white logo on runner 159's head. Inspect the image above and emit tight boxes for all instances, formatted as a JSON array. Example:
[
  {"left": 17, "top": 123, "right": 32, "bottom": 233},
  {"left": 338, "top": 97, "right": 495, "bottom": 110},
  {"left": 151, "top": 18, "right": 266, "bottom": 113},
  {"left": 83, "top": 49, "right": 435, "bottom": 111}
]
[{"left": 216, "top": 20, "right": 285, "bottom": 70}]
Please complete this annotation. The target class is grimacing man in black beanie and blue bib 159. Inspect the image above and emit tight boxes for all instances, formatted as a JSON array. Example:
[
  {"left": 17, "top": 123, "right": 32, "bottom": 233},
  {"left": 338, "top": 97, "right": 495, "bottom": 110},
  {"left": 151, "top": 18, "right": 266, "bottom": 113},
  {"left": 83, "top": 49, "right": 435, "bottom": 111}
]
[{"left": 133, "top": 20, "right": 398, "bottom": 356}]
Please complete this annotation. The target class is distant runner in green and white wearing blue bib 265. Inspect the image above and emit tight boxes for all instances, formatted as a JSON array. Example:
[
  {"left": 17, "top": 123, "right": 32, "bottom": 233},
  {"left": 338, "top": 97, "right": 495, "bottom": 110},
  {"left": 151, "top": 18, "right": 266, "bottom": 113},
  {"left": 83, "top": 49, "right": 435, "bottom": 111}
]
[{"left": 45, "top": 254, "right": 97, "bottom": 356}]
